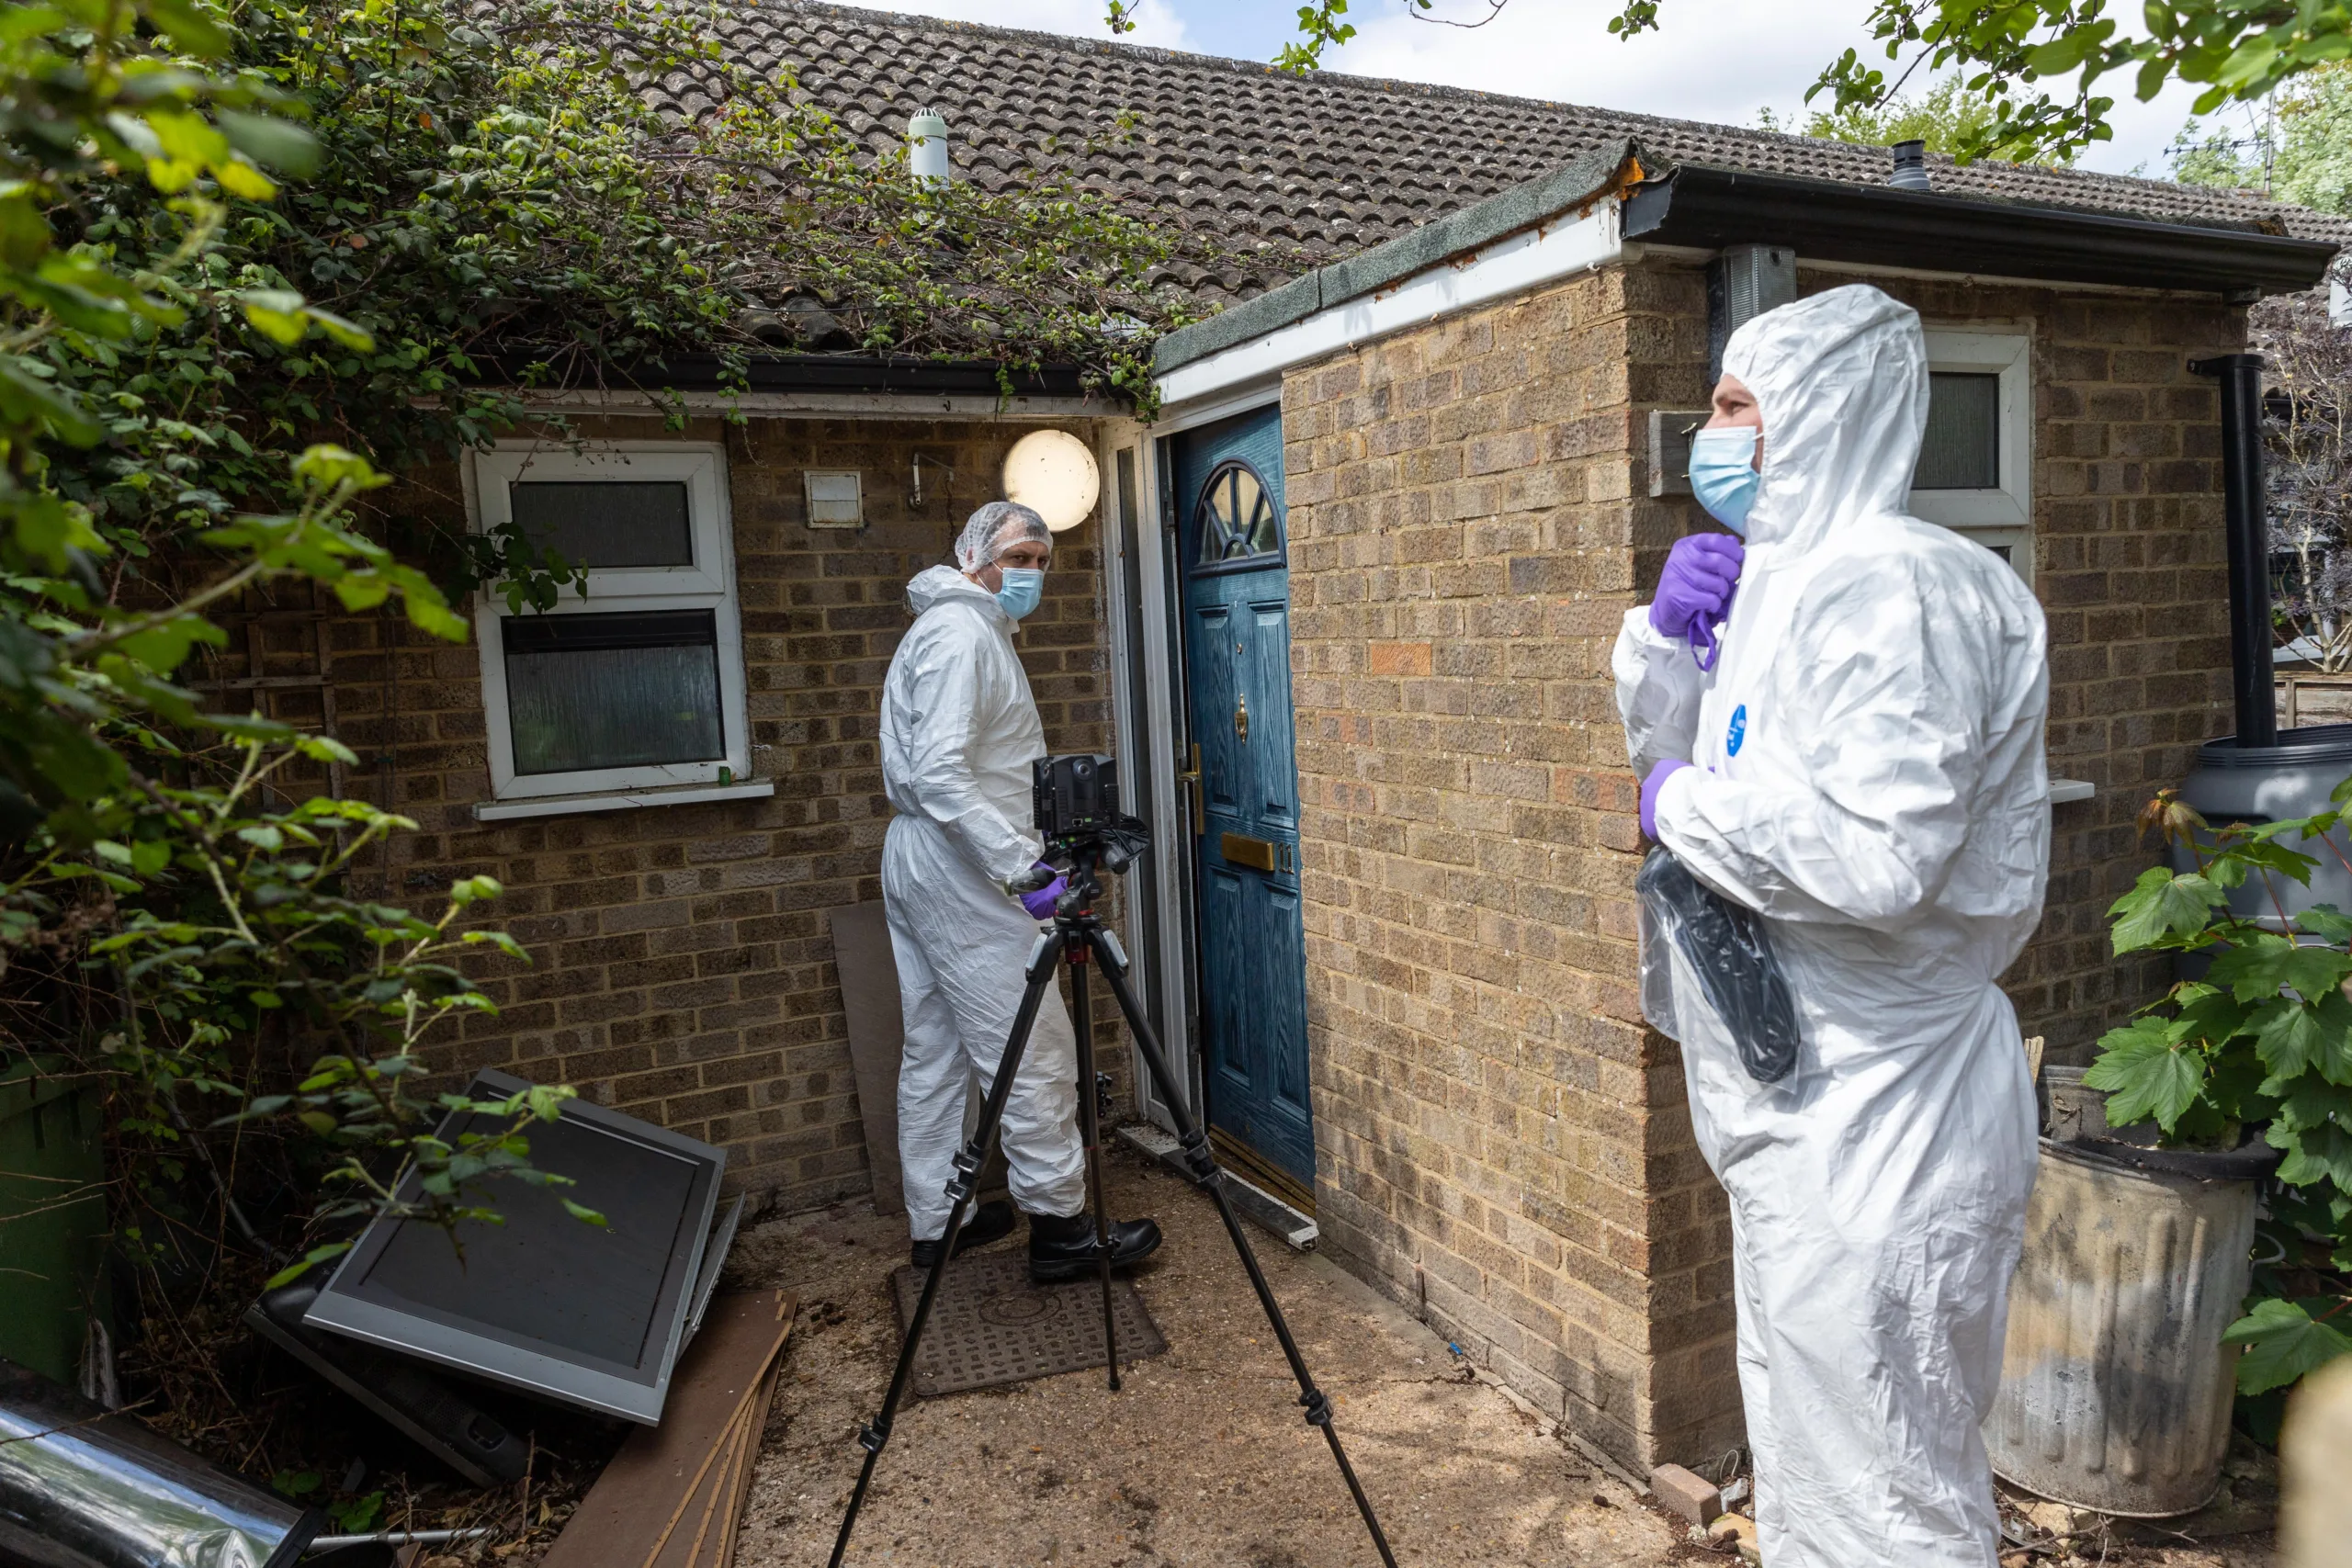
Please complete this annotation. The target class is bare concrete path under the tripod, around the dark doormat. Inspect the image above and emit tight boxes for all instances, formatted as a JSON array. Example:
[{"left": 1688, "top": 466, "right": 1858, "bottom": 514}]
[{"left": 729, "top": 1152, "right": 1674, "bottom": 1568}]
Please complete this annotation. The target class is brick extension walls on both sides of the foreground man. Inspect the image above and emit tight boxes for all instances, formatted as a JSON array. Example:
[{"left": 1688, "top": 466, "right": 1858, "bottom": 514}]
[{"left": 1284, "top": 264, "right": 2242, "bottom": 1464}]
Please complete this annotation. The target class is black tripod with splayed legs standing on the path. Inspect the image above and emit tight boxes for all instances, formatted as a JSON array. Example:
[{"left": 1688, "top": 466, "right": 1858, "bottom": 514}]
[{"left": 832, "top": 818, "right": 1397, "bottom": 1568}]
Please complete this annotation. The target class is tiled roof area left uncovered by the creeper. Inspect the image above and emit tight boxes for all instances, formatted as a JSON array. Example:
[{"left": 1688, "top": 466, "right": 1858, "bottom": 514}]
[{"left": 677, "top": 0, "right": 2352, "bottom": 296}]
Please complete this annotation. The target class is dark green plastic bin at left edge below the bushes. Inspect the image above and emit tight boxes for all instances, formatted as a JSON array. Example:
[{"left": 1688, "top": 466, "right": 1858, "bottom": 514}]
[{"left": 0, "top": 1055, "right": 113, "bottom": 1384}]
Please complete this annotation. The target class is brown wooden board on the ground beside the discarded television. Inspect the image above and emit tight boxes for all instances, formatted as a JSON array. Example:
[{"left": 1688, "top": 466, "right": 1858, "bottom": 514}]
[{"left": 541, "top": 1291, "right": 795, "bottom": 1568}]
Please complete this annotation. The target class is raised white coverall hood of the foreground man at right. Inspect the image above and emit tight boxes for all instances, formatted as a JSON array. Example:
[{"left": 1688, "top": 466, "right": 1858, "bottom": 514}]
[{"left": 1724, "top": 282, "right": 1927, "bottom": 550}]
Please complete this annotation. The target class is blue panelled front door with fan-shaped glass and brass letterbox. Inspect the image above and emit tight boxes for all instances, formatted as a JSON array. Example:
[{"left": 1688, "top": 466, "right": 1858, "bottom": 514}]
[{"left": 1171, "top": 409, "right": 1315, "bottom": 1192}]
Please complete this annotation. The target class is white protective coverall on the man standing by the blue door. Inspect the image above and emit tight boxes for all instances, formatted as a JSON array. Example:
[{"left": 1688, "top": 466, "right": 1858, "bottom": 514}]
[{"left": 882, "top": 567, "right": 1087, "bottom": 1241}]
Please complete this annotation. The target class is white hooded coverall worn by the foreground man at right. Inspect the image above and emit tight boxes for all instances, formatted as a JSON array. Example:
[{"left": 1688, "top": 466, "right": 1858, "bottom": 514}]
[{"left": 1613, "top": 285, "right": 2049, "bottom": 1568}]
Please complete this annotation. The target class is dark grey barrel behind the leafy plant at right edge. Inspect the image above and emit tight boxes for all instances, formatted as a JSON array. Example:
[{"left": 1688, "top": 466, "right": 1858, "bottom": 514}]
[{"left": 2173, "top": 724, "right": 2352, "bottom": 929}]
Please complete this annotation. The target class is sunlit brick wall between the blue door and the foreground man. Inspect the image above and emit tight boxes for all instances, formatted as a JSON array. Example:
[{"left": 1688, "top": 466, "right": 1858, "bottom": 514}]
[{"left": 1282, "top": 270, "right": 1731, "bottom": 1462}]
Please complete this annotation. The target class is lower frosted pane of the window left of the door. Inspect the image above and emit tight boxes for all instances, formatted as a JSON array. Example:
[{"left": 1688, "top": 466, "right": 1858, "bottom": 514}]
[{"left": 499, "top": 609, "right": 727, "bottom": 773}]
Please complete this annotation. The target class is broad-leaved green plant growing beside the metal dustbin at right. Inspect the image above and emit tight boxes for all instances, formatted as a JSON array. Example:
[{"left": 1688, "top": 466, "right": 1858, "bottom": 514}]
[{"left": 2084, "top": 799, "right": 2352, "bottom": 1394}]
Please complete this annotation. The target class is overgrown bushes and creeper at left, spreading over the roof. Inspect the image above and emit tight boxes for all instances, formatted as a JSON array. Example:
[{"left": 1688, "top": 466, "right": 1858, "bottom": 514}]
[{"left": 0, "top": 0, "right": 1216, "bottom": 1382}]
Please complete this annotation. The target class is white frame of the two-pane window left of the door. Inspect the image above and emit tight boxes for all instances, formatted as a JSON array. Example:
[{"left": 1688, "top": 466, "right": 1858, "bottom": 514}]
[{"left": 466, "top": 442, "right": 751, "bottom": 799}]
